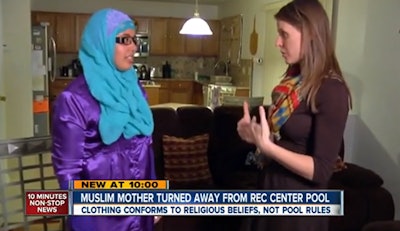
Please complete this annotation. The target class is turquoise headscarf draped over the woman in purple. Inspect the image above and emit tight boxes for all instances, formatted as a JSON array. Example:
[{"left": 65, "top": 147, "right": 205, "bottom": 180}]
[{"left": 79, "top": 9, "right": 154, "bottom": 144}]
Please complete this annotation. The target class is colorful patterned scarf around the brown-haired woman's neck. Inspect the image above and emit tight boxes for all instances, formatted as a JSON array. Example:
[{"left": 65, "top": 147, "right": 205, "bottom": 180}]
[{"left": 268, "top": 75, "right": 302, "bottom": 140}]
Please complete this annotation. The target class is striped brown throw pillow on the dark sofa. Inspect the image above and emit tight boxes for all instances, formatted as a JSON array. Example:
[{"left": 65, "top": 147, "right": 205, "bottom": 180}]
[{"left": 163, "top": 134, "right": 212, "bottom": 186}]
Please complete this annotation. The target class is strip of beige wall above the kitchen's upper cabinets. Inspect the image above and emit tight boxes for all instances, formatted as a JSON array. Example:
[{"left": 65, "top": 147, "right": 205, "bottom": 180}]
[{"left": 31, "top": 0, "right": 218, "bottom": 19}]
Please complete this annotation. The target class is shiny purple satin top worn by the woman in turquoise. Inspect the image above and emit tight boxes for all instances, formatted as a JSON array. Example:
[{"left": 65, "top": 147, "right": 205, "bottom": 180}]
[{"left": 52, "top": 76, "right": 156, "bottom": 231}]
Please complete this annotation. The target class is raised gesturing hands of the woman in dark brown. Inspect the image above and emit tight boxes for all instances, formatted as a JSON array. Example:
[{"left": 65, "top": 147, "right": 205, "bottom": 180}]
[{"left": 237, "top": 102, "right": 272, "bottom": 152}]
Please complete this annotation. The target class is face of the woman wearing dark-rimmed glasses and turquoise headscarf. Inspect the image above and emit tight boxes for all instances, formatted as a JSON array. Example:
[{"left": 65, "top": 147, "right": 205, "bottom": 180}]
[{"left": 114, "top": 29, "right": 137, "bottom": 71}]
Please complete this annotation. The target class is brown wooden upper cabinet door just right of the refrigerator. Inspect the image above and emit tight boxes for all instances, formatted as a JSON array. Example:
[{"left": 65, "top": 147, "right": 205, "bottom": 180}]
[{"left": 56, "top": 13, "right": 76, "bottom": 53}]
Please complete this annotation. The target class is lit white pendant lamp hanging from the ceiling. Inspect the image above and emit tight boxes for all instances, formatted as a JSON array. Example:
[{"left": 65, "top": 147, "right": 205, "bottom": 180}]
[{"left": 179, "top": 0, "right": 212, "bottom": 35}]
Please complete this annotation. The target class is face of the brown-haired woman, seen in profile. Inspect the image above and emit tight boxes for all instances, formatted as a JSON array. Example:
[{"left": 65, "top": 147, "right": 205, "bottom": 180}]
[{"left": 275, "top": 20, "right": 301, "bottom": 64}]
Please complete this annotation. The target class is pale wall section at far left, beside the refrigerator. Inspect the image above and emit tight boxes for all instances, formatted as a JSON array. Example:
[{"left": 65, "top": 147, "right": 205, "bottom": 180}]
[{"left": 1, "top": 0, "right": 33, "bottom": 138}]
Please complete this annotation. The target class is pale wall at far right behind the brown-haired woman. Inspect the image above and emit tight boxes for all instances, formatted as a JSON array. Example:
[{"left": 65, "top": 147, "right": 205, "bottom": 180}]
[{"left": 336, "top": 0, "right": 400, "bottom": 219}]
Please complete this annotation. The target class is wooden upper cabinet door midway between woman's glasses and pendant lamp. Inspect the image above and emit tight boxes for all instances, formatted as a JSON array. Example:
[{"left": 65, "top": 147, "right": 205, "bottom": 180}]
[{"left": 150, "top": 18, "right": 168, "bottom": 55}]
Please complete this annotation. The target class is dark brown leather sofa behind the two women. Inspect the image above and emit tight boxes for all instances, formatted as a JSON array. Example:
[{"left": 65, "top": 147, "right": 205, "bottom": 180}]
[{"left": 152, "top": 106, "right": 394, "bottom": 231}]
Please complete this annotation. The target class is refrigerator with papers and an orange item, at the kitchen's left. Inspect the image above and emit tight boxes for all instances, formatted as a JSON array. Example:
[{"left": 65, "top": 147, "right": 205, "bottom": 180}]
[{"left": 31, "top": 22, "right": 57, "bottom": 137}]
